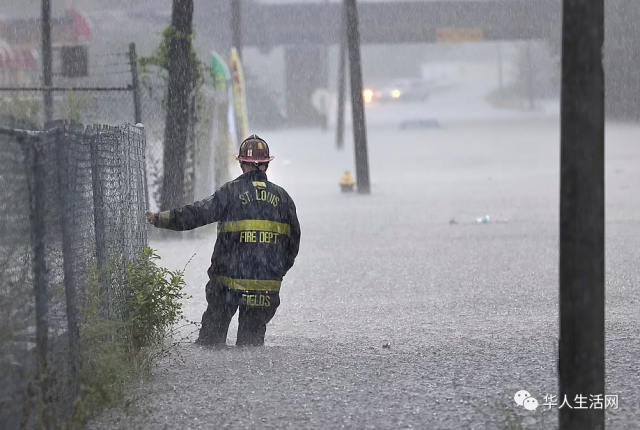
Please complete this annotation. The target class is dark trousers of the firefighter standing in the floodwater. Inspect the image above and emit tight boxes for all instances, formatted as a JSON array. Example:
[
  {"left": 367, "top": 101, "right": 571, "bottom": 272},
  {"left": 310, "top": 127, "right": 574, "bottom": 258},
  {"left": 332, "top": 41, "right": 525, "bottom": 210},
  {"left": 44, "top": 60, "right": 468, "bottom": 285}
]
[{"left": 197, "top": 281, "right": 280, "bottom": 346}]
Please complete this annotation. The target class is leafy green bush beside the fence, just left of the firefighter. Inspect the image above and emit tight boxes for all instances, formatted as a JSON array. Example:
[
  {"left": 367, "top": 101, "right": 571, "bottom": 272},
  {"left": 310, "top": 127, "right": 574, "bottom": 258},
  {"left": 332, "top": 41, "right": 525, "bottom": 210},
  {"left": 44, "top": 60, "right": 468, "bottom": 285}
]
[{"left": 69, "top": 248, "right": 190, "bottom": 429}]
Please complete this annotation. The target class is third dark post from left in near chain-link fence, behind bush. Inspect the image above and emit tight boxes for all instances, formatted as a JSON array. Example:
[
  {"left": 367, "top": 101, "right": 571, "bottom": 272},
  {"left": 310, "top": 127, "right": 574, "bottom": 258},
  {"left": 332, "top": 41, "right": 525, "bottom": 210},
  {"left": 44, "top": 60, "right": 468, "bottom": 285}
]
[{"left": 87, "top": 126, "right": 112, "bottom": 317}]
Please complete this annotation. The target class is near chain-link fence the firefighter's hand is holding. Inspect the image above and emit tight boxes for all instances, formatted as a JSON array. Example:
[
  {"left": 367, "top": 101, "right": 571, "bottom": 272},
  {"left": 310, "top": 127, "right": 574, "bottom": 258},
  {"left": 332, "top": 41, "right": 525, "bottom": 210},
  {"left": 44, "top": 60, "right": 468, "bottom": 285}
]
[{"left": 0, "top": 120, "right": 148, "bottom": 429}]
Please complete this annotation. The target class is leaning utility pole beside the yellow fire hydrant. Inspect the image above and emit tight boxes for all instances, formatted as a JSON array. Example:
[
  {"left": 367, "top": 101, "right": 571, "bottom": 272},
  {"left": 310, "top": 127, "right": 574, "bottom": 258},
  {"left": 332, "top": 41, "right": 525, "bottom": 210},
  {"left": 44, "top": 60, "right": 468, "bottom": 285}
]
[{"left": 345, "top": 0, "right": 371, "bottom": 194}]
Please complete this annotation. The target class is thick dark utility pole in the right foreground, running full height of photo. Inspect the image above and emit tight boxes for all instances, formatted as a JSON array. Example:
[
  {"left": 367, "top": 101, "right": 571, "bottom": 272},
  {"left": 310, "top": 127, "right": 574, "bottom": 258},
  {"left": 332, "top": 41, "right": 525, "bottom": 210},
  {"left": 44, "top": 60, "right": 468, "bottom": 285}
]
[{"left": 558, "top": 0, "right": 605, "bottom": 430}]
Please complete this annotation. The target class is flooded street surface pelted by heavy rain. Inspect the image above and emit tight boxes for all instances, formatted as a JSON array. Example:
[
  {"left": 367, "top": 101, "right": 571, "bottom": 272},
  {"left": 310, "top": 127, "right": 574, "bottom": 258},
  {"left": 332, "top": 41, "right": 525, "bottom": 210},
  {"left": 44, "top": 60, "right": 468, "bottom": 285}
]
[{"left": 89, "top": 120, "right": 640, "bottom": 429}]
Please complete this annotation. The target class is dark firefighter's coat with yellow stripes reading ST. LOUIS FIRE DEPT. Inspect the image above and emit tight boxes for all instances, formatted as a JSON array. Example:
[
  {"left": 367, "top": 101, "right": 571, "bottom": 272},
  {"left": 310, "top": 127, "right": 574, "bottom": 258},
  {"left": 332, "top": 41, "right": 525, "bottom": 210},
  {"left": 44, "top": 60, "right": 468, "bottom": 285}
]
[{"left": 155, "top": 170, "right": 300, "bottom": 293}]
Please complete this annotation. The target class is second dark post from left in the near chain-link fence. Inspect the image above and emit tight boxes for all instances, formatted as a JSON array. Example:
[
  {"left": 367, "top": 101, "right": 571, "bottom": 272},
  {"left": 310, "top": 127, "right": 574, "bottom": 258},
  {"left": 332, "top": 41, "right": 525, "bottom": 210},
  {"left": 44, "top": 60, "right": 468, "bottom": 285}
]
[{"left": 55, "top": 126, "right": 80, "bottom": 402}]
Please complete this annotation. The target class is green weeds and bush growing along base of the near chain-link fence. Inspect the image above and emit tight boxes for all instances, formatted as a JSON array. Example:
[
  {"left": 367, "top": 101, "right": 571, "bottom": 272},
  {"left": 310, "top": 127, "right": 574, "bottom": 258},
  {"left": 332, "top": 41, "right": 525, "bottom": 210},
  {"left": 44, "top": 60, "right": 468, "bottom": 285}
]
[{"left": 6, "top": 248, "right": 193, "bottom": 430}]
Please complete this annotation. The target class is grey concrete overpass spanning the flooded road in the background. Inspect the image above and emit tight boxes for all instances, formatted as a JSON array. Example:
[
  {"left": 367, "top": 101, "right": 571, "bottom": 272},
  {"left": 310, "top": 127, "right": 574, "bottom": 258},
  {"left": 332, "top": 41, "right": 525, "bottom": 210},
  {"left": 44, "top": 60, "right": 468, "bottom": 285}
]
[{"left": 196, "top": 0, "right": 640, "bottom": 125}]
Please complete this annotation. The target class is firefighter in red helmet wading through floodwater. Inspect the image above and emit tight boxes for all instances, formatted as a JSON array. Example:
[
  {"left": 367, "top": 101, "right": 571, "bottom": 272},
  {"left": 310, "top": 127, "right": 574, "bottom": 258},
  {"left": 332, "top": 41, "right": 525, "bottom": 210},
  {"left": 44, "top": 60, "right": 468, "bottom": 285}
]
[{"left": 147, "top": 134, "right": 300, "bottom": 346}]
